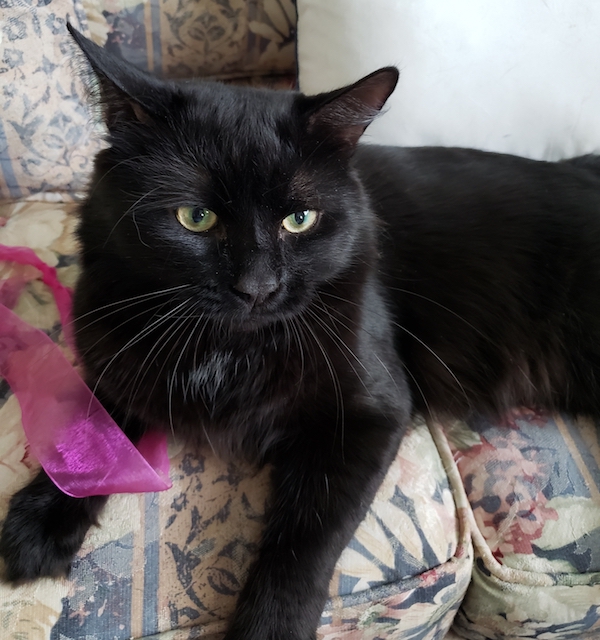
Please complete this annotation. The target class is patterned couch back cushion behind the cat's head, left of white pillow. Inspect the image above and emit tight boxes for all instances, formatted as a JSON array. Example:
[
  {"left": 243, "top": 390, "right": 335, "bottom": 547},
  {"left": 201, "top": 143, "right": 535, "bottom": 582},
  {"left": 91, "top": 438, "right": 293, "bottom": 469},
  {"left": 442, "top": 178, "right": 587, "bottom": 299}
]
[{"left": 0, "top": 0, "right": 296, "bottom": 200}]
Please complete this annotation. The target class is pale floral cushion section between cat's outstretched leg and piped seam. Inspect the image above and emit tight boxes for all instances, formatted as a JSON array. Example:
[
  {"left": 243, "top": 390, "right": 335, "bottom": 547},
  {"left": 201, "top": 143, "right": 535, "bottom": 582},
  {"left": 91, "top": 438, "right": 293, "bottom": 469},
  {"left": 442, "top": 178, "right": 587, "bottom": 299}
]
[{"left": 319, "top": 422, "right": 473, "bottom": 640}]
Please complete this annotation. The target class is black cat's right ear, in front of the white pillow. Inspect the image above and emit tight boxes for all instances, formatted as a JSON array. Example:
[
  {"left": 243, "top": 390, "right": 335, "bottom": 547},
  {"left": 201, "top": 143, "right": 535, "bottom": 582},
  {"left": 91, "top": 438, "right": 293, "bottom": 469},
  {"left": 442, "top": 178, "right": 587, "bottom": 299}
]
[{"left": 300, "top": 67, "right": 399, "bottom": 148}]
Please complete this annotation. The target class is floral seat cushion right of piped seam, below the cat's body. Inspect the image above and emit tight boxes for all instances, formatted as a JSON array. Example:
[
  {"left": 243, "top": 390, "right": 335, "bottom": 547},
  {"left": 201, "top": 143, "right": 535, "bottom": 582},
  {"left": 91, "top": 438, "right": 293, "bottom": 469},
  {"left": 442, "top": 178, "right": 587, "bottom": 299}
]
[{"left": 450, "top": 409, "right": 600, "bottom": 640}]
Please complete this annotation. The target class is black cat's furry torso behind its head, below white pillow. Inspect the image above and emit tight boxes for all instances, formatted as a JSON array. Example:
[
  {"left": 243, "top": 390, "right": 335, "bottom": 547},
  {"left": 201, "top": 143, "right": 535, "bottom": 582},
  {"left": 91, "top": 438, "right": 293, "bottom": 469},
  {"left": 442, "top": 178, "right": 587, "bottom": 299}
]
[{"left": 355, "top": 146, "right": 600, "bottom": 415}]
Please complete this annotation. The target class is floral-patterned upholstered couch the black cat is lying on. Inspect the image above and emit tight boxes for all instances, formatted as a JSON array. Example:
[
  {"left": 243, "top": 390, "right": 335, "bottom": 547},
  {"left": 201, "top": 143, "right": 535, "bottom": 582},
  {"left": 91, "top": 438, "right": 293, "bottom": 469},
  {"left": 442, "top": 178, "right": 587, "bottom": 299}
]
[{"left": 0, "top": 0, "right": 600, "bottom": 640}]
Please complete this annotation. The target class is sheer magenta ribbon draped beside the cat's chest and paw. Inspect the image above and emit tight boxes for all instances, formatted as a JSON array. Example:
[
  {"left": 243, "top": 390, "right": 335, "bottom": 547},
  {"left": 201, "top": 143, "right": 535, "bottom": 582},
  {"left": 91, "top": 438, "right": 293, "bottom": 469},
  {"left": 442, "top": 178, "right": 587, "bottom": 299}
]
[{"left": 0, "top": 245, "right": 172, "bottom": 498}]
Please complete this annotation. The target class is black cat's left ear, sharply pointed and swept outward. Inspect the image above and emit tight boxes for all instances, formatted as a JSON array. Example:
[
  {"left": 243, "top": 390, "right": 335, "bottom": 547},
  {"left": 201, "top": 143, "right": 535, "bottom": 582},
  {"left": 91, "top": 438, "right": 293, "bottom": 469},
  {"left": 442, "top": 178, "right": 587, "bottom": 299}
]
[{"left": 67, "top": 24, "right": 166, "bottom": 130}]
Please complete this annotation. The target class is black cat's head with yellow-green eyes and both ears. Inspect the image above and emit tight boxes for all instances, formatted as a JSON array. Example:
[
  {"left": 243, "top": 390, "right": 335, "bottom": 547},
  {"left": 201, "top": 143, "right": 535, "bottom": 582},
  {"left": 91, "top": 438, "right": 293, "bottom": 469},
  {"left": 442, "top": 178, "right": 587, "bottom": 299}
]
[{"left": 71, "top": 29, "right": 398, "bottom": 326}]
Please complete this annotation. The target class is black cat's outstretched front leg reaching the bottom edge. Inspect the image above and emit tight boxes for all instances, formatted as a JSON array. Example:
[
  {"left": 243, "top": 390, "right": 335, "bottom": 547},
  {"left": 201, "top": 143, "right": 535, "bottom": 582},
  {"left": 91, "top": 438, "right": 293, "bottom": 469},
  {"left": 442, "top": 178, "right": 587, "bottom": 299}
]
[{"left": 225, "top": 404, "right": 402, "bottom": 640}]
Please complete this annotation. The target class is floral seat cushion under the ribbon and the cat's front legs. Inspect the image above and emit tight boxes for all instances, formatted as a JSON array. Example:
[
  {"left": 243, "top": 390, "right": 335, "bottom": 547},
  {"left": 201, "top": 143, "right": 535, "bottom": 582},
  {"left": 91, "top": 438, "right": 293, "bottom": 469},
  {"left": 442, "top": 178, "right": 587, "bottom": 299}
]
[{"left": 0, "top": 202, "right": 473, "bottom": 640}]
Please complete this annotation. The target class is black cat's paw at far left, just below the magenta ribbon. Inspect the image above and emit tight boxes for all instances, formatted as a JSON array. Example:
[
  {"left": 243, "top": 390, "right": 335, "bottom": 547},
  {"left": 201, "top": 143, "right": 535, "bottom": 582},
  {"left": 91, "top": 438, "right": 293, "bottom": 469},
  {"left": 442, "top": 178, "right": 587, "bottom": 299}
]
[{"left": 0, "top": 472, "right": 106, "bottom": 584}]
